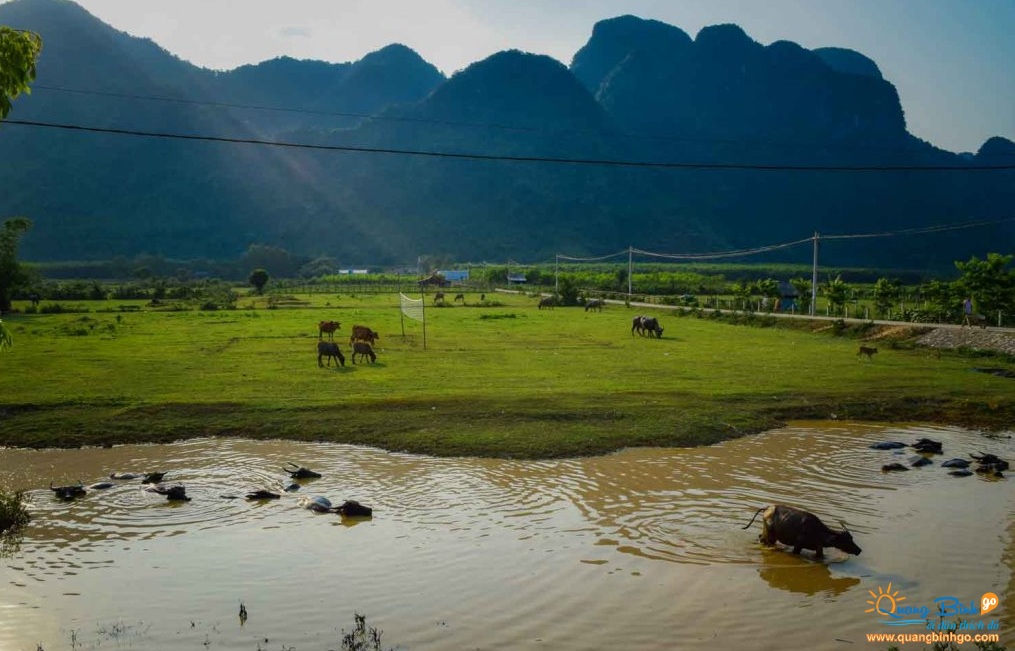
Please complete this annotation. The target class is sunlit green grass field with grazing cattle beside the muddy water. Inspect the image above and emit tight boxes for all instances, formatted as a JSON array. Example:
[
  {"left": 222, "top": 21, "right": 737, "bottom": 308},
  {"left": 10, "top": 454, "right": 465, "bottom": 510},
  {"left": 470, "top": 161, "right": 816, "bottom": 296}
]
[{"left": 0, "top": 294, "right": 1015, "bottom": 458}]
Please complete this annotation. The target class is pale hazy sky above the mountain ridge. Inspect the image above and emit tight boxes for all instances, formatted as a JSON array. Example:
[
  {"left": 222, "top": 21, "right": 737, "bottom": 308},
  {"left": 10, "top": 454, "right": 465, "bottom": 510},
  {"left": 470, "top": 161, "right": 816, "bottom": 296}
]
[{"left": 3, "top": 0, "right": 1015, "bottom": 151}]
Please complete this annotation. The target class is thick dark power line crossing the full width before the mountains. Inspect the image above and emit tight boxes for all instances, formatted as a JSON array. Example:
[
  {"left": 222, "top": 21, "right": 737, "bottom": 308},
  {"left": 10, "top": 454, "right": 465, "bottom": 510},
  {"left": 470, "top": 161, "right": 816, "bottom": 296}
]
[{"left": 4, "top": 119, "right": 1015, "bottom": 173}]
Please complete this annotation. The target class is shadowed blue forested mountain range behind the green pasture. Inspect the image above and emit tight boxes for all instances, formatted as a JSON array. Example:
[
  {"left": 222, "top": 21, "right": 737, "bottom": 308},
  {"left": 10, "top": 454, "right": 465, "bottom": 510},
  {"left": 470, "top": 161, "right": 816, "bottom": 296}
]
[{"left": 0, "top": 0, "right": 1015, "bottom": 268}]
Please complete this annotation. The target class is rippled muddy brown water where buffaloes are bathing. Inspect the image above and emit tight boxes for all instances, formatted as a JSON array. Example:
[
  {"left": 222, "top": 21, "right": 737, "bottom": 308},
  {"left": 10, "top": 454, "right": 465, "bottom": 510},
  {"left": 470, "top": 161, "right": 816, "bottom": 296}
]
[{"left": 0, "top": 422, "right": 1015, "bottom": 651}]
